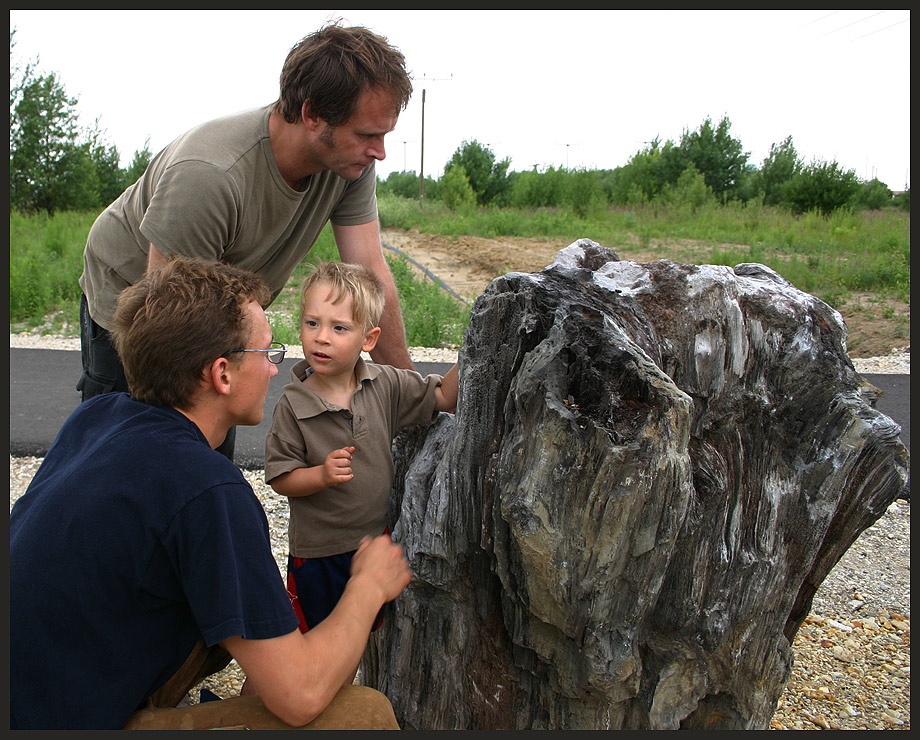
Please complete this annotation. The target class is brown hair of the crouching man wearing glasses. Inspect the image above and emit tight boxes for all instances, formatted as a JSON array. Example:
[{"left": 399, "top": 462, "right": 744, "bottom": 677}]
[{"left": 112, "top": 257, "right": 271, "bottom": 409}]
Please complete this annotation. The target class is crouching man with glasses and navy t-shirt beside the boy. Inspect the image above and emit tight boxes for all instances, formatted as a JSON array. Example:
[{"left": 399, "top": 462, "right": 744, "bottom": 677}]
[{"left": 10, "top": 258, "right": 410, "bottom": 729}]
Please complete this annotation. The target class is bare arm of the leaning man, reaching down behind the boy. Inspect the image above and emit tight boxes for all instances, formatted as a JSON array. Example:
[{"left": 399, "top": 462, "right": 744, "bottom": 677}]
[{"left": 332, "top": 220, "right": 414, "bottom": 370}]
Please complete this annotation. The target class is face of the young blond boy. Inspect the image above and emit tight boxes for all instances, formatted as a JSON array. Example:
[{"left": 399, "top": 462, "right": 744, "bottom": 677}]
[{"left": 300, "top": 283, "right": 380, "bottom": 376}]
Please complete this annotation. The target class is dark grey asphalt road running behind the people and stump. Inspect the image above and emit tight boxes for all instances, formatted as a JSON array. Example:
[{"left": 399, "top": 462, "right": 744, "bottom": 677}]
[{"left": 10, "top": 347, "right": 910, "bottom": 469}]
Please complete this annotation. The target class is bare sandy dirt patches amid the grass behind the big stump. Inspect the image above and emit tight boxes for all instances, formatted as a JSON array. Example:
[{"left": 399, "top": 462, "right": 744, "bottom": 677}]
[{"left": 381, "top": 230, "right": 910, "bottom": 357}]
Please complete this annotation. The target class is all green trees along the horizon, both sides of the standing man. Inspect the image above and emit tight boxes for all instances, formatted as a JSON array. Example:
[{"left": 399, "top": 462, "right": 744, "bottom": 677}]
[{"left": 10, "top": 29, "right": 910, "bottom": 217}]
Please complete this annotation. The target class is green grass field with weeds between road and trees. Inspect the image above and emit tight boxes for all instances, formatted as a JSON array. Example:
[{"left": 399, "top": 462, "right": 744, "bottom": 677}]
[{"left": 10, "top": 196, "right": 910, "bottom": 356}]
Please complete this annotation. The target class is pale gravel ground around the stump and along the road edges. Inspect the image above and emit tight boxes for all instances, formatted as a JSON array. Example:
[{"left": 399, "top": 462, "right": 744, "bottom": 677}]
[{"left": 10, "top": 334, "right": 910, "bottom": 730}]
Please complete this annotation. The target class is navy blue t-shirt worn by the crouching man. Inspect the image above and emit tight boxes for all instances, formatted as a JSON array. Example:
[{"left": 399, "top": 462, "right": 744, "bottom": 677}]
[{"left": 10, "top": 393, "right": 297, "bottom": 729}]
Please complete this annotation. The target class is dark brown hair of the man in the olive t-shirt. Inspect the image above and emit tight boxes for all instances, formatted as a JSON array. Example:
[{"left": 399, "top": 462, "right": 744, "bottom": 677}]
[{"left": 276, "top": 24, "right": 412, "bottom": 127}]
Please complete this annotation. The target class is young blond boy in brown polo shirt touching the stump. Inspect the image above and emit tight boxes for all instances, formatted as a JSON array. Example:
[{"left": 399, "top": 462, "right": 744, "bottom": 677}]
[{"left": 265, "top": 262, "right": 459, "bottom": 632}]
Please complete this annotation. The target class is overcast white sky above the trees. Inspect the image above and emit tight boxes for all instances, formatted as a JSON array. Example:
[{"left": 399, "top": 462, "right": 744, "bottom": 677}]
[{"left": 10, "top": 10, "right": 910, "bottom": 190}]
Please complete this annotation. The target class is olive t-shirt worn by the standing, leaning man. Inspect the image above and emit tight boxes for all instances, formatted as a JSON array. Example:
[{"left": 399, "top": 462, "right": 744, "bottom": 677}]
[{"left": 80, "top": 106, "right": 377, "bottom": 329}]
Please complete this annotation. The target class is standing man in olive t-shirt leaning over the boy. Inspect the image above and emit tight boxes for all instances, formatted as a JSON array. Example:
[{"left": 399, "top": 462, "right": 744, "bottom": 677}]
[{"left": 77, "top": 25, "right": 412, "bottom": 456}]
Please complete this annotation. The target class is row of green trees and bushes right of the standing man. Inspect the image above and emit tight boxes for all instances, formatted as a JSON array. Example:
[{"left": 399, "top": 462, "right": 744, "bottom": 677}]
[{"left": 378, "top": 116, "right": 910, "bottom": 217}]
